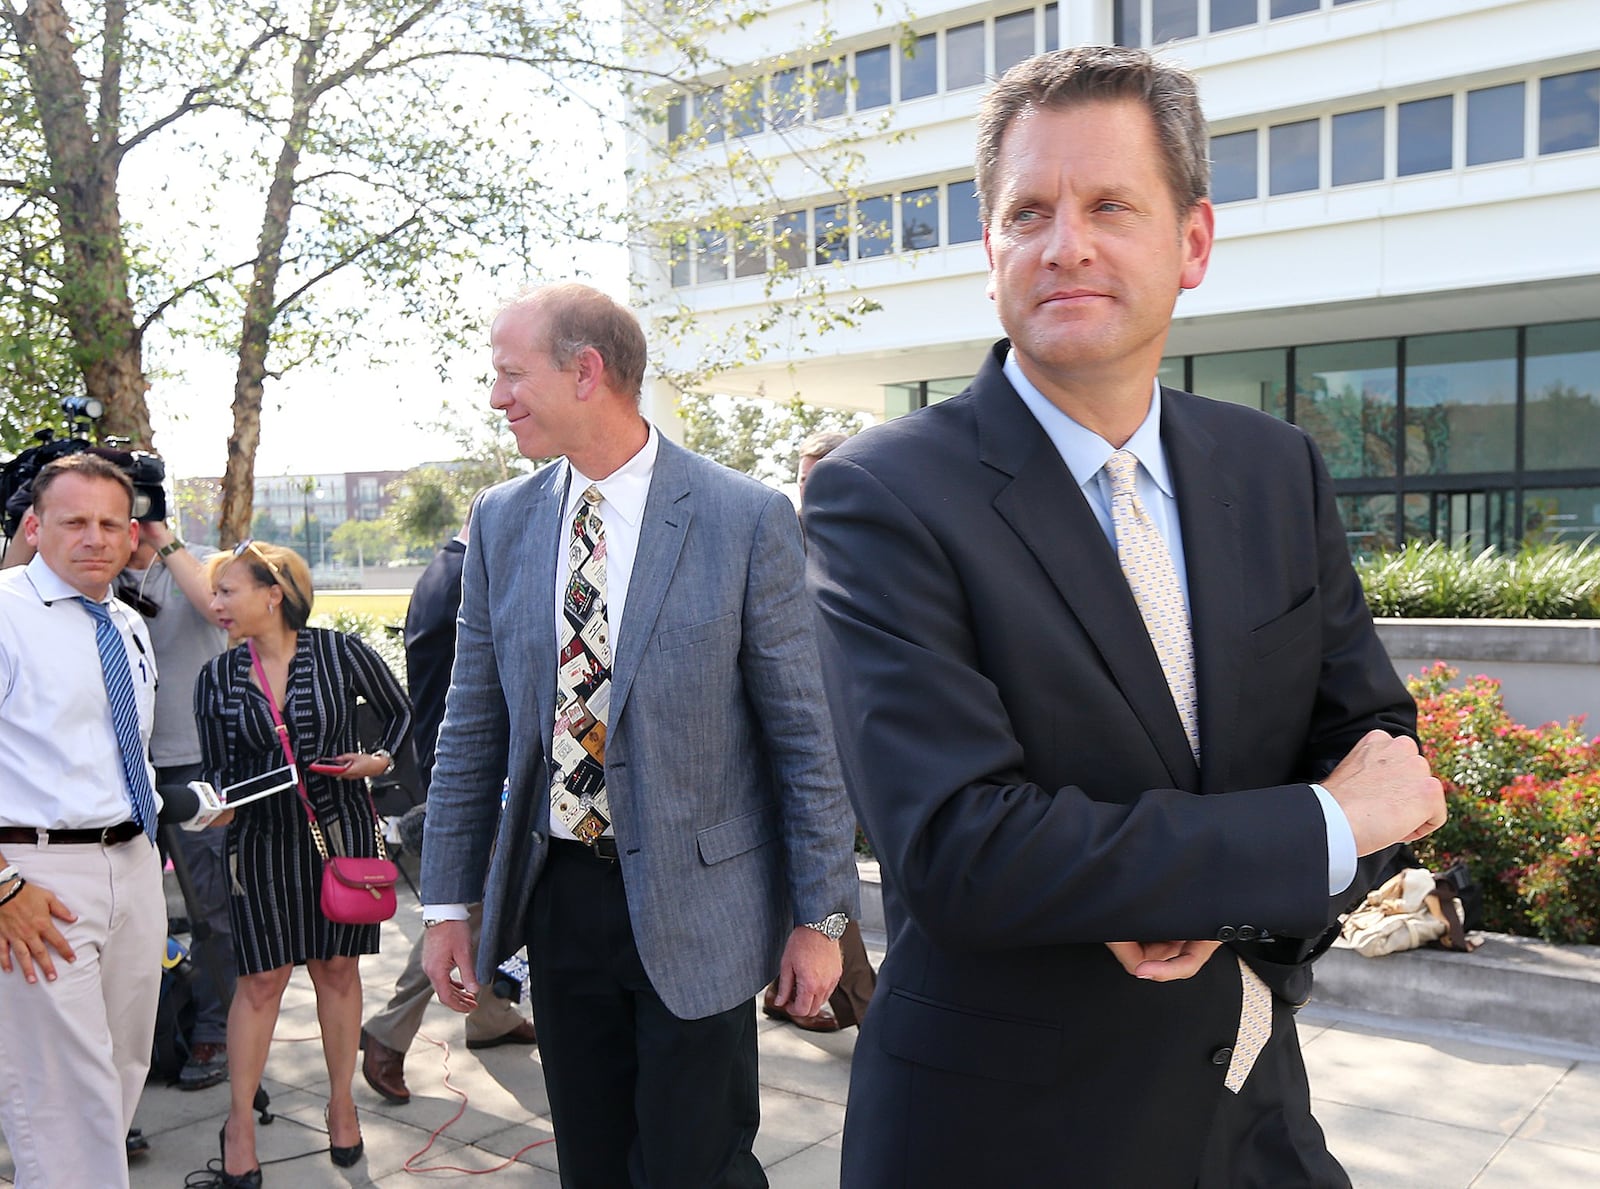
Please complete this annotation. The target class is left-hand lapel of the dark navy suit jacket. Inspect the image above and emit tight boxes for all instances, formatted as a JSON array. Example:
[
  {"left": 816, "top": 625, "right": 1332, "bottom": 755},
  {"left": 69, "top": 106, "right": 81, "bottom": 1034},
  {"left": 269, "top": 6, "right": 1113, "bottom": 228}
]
[{"left": 973, "top": 355, "right": 1197, "bottom": 789}]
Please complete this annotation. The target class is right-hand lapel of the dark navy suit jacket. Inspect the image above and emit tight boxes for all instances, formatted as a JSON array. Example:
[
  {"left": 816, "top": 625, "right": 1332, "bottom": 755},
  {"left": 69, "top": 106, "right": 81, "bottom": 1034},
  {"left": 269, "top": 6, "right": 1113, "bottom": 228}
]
[{"left": 1162, "top": 389, "right": 1245, "bottom": 792}]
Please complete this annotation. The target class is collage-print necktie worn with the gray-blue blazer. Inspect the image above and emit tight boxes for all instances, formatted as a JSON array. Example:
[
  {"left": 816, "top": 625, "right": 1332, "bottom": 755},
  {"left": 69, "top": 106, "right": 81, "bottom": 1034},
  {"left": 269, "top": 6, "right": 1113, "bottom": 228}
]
[{"left": 550, "top": 483, "right": 611, "bottom": 842}]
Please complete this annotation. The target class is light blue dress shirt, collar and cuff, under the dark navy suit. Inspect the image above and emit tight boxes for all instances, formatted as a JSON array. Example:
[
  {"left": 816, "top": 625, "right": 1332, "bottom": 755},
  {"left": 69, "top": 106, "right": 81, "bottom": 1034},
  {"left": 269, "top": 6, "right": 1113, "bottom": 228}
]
[{"left": 1003, "top": 350, "right": 1357, "bottom": 896}]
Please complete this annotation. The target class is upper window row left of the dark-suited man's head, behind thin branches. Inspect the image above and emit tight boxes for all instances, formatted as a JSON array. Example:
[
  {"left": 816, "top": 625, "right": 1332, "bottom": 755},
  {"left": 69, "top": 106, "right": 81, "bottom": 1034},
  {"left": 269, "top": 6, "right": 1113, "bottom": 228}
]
[{"left": 667, "top": 3, "right": 1059, "bottom": 144}]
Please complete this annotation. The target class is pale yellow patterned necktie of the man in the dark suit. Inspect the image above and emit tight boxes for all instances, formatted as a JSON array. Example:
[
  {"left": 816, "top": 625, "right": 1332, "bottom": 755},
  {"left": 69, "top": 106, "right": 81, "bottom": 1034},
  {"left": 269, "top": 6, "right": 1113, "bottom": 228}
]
[{"left": 1106, "top": 450, "right": 1272, "bottom": 1095}]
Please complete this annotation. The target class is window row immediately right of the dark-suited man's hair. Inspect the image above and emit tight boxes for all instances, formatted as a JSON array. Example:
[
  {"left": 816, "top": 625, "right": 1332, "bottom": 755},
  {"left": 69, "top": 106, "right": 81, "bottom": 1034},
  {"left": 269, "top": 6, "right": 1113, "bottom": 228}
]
[{"left": 1211, "top": 69, "right": 1600, "bottom": 203}]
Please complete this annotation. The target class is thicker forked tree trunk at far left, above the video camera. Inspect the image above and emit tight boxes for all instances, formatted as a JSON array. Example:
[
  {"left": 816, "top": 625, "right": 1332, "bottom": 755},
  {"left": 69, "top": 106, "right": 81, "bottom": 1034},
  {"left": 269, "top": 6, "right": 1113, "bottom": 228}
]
[{"left": 8, "top": 0, "right": 154, "bottom": 446}]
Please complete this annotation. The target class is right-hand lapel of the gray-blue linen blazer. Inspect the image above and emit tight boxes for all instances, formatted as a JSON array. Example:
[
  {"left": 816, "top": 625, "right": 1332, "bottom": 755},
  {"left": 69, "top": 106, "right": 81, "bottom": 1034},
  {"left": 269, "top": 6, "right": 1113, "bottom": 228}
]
[{"left": 604, "top": 437, "right": 694, "bottom": 735}]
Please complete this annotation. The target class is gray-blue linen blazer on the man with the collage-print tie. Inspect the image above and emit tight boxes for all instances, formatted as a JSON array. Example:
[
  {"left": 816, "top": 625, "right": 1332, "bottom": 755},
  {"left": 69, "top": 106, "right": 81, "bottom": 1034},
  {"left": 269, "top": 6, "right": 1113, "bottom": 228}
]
[{"left": 422, "top": 437, "right": 858, "bottom": 1019}]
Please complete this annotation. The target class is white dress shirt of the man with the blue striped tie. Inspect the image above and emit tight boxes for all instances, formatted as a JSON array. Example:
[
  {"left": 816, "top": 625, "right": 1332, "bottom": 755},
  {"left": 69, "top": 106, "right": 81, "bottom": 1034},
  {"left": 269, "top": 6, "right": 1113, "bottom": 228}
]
[{"left": 0, "top": 555, "right": 162, "bottom": 829}]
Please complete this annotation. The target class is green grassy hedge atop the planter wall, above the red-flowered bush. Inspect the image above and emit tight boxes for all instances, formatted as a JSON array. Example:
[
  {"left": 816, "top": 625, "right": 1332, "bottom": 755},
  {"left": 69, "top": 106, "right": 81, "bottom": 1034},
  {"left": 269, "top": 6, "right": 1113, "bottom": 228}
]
[{"left": 1355, "top": 541, "right": 1600, "bottom": 619}]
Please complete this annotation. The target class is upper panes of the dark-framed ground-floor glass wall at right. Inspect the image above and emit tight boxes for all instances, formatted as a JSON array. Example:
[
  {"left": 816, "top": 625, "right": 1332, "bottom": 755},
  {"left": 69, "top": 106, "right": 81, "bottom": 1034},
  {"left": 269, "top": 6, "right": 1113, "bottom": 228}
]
[{"left": 1162, "top": 320, "right": 1600, "bottom": 480}]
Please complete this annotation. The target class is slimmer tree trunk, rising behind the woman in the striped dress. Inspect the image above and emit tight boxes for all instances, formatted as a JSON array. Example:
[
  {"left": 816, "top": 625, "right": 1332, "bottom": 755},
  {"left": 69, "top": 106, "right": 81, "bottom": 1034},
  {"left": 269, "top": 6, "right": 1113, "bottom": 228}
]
[{"left": 218, "top": 0, "right": 338, "bottom": 549}]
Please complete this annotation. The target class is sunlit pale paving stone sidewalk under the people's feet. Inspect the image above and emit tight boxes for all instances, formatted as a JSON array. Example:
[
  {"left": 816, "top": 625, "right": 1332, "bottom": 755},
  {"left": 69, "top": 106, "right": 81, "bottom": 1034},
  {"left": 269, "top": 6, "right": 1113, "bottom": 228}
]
[{"left": 0, "top": 906, "right": 1600, "bottom": 1189}]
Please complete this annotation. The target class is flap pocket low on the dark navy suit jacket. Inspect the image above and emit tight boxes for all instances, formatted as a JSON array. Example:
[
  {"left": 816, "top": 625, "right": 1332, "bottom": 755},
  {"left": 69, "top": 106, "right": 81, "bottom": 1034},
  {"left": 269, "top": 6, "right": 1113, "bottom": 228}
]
[{"left": 872, "top": 989, "right": 1062, "bottom": 1085}]
